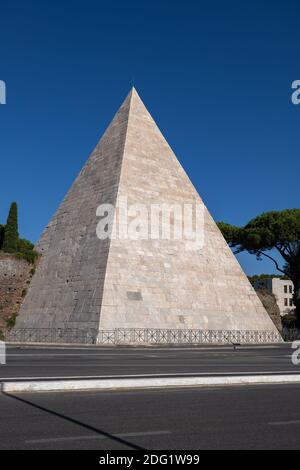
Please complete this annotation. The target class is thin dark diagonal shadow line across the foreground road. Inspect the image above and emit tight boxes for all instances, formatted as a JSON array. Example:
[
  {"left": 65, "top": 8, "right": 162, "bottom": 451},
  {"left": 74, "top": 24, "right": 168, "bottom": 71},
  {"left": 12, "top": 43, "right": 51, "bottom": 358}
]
[{"left": 2, "top": 392, "right": 145, "bottom": 450}]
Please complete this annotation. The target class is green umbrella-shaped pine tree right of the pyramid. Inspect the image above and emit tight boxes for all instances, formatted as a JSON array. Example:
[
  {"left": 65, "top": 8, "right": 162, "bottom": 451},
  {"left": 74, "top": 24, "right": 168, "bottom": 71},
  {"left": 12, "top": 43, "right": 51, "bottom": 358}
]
[{"left": 218, "top": 209, "right": 300, "bottom": 328}]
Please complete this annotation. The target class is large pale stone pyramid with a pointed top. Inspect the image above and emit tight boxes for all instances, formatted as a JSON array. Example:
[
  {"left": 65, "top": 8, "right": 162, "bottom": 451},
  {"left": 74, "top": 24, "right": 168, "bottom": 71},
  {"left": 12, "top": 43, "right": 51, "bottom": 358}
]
[{"left": 14, "top": 89, "right": 281, "bottom": 343}]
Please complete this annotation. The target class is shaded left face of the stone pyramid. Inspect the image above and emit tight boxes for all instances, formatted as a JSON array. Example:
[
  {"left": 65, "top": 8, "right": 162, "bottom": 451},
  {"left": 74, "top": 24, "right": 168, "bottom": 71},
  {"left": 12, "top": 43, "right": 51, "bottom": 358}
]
[{"left": 17, "top": 90, "right": 130, "bottom": 328}]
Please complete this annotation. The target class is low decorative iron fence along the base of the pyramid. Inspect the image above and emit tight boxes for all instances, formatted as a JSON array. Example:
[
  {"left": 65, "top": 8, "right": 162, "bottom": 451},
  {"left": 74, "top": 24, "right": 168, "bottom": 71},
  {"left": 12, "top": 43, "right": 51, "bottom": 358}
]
[{"left": 6, "top": 328, "right": 283, "bottom": 345}]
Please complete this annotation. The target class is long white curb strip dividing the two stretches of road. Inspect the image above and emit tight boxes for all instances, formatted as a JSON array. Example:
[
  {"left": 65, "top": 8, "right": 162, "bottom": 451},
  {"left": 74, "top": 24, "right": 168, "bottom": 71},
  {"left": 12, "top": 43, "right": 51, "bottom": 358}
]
[{"left": 1, "top": 375, "right": 300, "bottom": 392}]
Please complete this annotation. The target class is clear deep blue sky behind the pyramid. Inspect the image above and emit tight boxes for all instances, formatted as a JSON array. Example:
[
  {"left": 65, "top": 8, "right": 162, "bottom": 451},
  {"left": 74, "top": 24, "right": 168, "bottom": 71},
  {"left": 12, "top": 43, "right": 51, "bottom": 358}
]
[{"left": 0, "top": 0, "right": 300, "bottom": 274}]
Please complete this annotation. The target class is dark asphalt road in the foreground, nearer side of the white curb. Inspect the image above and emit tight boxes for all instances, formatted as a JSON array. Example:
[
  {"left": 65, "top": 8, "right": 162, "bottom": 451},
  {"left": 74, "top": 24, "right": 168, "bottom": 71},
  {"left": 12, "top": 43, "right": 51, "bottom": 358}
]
[{"left": 0, "top": 385, "right": 300, "bottom": 450}]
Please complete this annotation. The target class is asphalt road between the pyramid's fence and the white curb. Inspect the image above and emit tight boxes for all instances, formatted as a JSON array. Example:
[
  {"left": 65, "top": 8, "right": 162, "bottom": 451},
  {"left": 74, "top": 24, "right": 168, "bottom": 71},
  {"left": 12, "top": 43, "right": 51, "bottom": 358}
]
[{"left": 0, "top": 344, "right": 300, "bottom": 381}]
